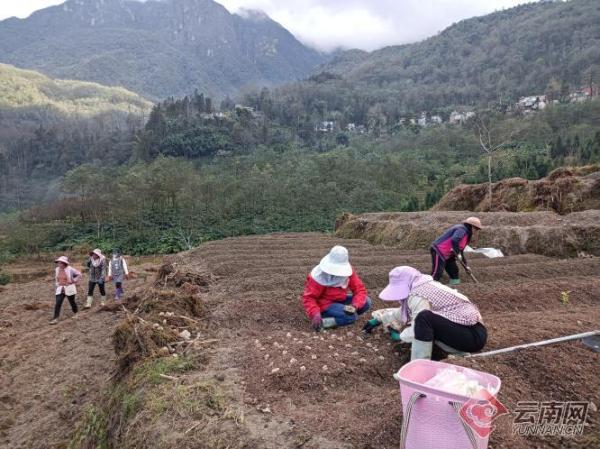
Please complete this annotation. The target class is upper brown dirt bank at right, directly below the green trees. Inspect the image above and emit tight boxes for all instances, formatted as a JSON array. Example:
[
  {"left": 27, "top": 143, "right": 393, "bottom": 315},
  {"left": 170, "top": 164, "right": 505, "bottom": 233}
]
[{"left": 432, "top": 166, "right": 600, "bottom": 214}]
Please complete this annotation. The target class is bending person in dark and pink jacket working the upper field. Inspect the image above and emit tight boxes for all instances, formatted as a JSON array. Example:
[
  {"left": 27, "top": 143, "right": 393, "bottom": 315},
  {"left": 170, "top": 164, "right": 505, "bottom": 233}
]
[{"left": 430, "top": 217, "right": 482, "bottom": 285}]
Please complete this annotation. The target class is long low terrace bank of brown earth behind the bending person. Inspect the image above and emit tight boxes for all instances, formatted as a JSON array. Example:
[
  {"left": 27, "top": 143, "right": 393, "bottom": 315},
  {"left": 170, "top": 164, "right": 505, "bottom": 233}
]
[{"left": 336, "top": 210, "right": 600, "bottom": 257}]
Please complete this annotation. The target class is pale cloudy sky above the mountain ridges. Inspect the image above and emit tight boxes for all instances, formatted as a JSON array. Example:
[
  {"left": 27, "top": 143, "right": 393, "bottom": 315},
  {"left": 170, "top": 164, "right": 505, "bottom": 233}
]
[{"left": 0, "top": 0, "right": 536, "bottom": 50}]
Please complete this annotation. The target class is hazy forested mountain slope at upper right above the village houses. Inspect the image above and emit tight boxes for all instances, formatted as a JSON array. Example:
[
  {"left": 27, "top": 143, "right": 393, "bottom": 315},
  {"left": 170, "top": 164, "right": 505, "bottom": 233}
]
[{"left": 319, "top": 0, "right": 600, "bottom": 112}]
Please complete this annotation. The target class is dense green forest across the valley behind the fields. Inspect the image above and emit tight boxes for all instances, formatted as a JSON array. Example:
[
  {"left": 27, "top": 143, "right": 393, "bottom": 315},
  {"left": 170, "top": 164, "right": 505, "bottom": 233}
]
[{"left": 0, "top": 90, "right": 600, "bottom": 257}]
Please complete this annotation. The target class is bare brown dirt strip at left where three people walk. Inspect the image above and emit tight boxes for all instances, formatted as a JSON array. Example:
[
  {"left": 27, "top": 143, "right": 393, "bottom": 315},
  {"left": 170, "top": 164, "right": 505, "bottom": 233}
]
[{"left": 0, "top": 258, "right": 155, "bottom": 449}]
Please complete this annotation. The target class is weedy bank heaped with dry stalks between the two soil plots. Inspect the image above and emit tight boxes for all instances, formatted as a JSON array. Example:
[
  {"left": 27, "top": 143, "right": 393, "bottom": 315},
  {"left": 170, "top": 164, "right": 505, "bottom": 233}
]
[{"left": 72, "top": 274, "right": 223, "bottom": 449}]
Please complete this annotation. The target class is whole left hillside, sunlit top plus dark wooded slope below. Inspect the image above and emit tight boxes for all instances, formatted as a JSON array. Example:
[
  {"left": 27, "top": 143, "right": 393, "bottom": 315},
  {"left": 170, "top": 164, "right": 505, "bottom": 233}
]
[{"left": 0, "top": 64, "right": 152, "bottom": 211}]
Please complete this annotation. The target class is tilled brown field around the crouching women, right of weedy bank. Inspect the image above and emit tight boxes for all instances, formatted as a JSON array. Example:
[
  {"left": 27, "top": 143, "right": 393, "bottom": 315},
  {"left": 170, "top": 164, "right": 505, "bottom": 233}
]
[{"left": 165, "top": 234, "right": 600, "bottom": 449}]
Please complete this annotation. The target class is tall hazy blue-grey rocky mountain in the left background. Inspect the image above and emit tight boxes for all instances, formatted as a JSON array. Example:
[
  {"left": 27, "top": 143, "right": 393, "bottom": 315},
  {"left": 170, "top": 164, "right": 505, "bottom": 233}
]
[{"left": 0, "top": 0, "right": 324, "bottom": 99}]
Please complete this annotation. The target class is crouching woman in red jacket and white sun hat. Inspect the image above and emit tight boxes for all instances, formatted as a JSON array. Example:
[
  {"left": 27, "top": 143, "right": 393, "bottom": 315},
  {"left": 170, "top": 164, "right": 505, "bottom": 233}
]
[{"left": 302, "top": 246, "right": 371, "bottom": 332}]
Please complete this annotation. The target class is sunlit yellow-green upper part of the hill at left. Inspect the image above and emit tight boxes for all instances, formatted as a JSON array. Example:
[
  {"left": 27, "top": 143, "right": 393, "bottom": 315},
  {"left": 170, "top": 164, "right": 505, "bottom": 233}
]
[{"left": 0, "top": 64, "right": 152, "bottom": 142}]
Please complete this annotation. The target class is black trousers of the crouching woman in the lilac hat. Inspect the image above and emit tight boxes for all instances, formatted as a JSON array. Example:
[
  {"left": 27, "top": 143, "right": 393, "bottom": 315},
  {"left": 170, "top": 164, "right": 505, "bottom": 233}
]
[{"left": 414, "top": 310, "right": 487, "bottom": 352}]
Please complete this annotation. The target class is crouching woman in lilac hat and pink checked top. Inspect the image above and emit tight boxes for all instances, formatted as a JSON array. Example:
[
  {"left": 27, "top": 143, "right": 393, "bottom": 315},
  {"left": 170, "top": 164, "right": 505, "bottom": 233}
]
[{"left": 363, "top": 266, "right": 487, "bottom": 360}]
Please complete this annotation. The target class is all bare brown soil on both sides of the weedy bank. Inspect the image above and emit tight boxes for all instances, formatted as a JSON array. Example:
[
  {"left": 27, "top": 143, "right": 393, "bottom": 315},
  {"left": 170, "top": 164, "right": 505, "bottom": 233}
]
[{"left": 0, "top": 233, "right": 600, "bottom": 449}]
